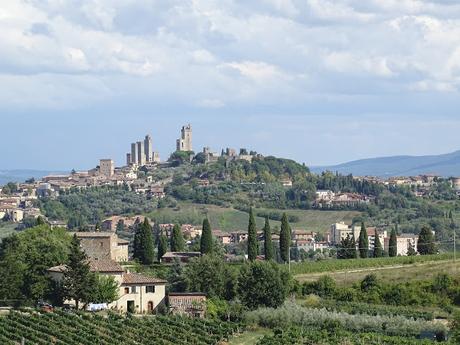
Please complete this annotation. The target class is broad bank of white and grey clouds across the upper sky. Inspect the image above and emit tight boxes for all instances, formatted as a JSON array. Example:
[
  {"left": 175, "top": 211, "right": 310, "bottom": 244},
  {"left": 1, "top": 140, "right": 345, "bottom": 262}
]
[{"left": 0, "top": 0, "right": 460, "bottom": 107}]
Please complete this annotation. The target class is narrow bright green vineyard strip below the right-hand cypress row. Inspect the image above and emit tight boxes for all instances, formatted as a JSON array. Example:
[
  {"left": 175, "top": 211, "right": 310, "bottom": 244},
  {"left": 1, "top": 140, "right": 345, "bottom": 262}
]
[{"left": 291, "top": 253, "right": 453, "bottom": 275}]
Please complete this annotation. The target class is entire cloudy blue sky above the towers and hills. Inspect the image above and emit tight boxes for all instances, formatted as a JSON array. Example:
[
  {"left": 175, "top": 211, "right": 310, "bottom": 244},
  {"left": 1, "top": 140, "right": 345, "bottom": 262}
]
[{"left": 0, "top": 0, "right": 460, "bottom": 170}]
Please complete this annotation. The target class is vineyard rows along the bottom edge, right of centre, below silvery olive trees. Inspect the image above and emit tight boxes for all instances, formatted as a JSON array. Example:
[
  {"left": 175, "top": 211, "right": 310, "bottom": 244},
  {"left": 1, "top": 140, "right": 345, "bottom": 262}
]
[{"left": 257, "top": 328, "right": 440, "bottom": 345}]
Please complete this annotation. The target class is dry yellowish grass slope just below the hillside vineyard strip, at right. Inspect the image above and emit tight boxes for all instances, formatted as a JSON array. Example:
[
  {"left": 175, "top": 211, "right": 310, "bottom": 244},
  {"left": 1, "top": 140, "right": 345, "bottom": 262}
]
[{"left": 296, "top": 260, "right": 460, "bottom": 285}]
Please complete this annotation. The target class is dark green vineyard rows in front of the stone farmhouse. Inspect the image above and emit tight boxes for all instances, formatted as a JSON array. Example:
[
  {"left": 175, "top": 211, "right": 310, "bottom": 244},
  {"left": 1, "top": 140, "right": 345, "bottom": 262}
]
[{"left": 0, "top": 312, "right": 243, "bottom": 345}]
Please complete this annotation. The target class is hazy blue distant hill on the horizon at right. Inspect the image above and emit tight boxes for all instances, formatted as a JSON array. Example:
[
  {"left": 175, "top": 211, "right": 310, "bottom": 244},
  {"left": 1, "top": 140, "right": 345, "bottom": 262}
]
[{"left": 310, "top": 151, "right": 460, "bottom": 177}]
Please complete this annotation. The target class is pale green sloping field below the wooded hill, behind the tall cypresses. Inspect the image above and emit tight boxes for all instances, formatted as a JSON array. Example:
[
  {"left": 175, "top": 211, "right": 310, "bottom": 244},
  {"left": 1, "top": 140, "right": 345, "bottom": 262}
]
[{"left": 149, "top": 203, "right": 359, "bottom": 233}]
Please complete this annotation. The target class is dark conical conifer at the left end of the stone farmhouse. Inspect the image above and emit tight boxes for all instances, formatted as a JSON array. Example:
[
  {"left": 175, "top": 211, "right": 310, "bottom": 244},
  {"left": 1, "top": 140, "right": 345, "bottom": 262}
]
[{"left": 62, "top": 235, "right": 97, "bottom": 309}]
